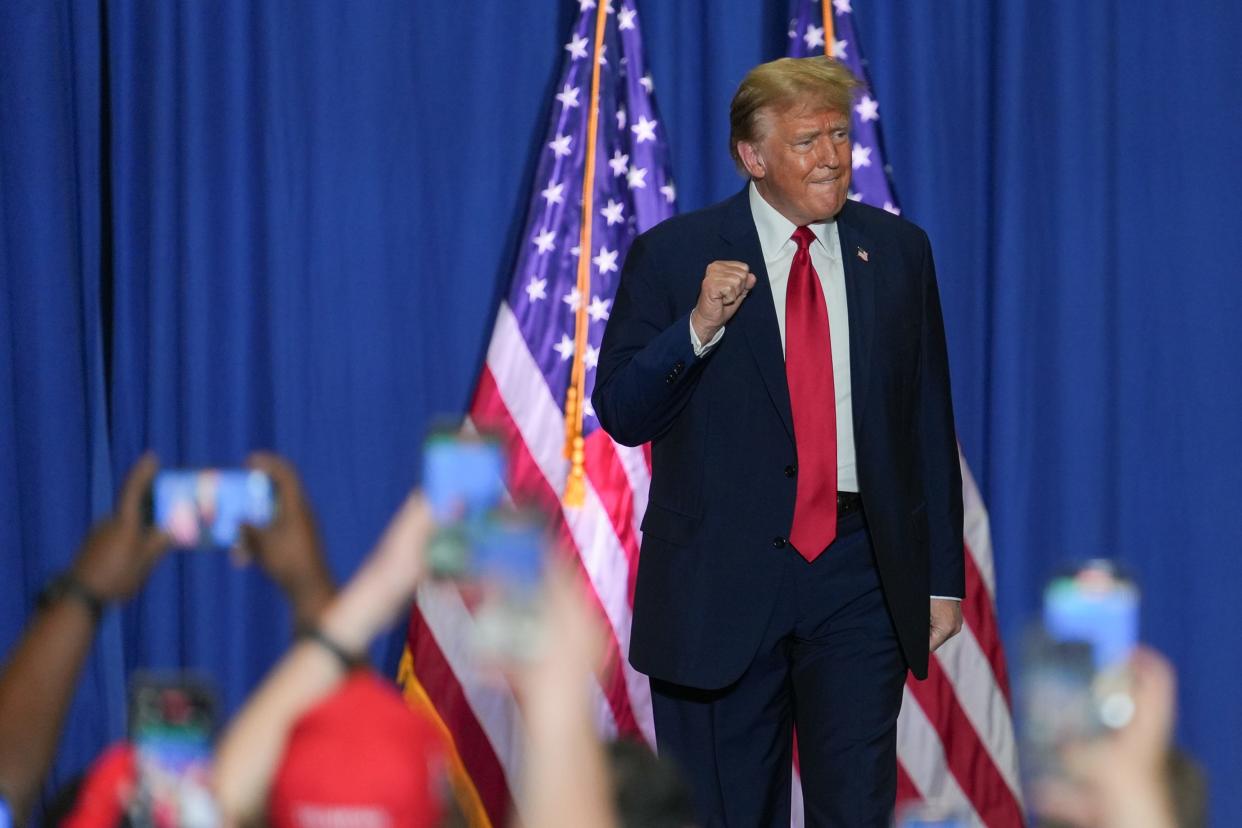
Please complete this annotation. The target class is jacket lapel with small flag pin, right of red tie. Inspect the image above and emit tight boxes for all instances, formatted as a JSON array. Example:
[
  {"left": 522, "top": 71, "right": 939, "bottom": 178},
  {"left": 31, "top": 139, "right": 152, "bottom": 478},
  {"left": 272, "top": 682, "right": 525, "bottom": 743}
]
[{"left": 837, "top": 201, "right": 881, "bottom": 433}]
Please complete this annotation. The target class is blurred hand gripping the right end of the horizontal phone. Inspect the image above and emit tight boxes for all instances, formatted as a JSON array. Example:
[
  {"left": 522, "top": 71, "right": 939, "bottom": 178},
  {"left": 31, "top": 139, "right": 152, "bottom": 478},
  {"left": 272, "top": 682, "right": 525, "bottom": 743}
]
[{"left": 233, "top": 452, "right": 337, "bottom": 626}]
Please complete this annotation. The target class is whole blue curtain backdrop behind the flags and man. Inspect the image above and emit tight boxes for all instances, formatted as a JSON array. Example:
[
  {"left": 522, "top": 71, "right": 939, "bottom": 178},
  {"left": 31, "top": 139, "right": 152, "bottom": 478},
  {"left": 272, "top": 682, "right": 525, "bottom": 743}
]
[{"left": 0, "top": 0, "right": 1242, "bottom": 826}]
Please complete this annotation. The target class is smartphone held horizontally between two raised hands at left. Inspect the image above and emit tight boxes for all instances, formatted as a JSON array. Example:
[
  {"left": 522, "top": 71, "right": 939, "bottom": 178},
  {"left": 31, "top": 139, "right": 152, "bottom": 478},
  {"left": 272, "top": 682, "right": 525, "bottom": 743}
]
[{"left": 149, "top": 468, "right": 277, "bottom": 549}]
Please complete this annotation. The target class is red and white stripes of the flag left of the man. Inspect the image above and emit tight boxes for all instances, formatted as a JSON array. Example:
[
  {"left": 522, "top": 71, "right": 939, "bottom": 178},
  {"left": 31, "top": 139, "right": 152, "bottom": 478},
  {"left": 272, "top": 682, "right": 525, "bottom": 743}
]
[{"left": 410, "top": 303, "right": 655, "bottom": 824}]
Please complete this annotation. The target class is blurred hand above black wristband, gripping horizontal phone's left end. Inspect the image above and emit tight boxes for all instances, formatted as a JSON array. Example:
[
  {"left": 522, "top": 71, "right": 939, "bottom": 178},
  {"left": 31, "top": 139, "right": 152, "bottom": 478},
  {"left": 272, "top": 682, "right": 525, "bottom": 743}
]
[{"left": 72, "top": 452, "right": 170, "bottom": 602}]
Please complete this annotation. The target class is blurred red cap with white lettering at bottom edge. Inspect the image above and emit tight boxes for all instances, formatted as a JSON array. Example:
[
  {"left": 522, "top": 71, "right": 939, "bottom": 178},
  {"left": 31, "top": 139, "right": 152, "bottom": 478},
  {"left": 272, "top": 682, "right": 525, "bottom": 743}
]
[{"left": 267, "top": 672, "right": 451, "bottom": 828}]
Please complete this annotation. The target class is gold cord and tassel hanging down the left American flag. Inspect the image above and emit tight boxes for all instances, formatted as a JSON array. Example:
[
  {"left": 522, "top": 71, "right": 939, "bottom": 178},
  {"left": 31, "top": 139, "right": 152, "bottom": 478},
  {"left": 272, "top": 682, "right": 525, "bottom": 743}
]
[{"left": 561, "top": 2, "right": 609, "bottom": 506}]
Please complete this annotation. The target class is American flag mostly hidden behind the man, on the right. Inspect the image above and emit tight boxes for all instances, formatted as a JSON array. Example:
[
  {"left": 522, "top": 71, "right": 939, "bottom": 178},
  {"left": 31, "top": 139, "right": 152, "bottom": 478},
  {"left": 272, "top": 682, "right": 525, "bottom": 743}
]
[{"left": 789, "top": 0, "right": 1023, "bottom": 828}]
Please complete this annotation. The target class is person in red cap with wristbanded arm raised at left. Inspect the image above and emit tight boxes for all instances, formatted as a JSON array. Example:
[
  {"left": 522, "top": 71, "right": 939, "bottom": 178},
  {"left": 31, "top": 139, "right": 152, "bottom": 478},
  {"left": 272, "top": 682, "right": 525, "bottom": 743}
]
[{"left": 214, "top": 494, "right": 448, "bottom": 826}]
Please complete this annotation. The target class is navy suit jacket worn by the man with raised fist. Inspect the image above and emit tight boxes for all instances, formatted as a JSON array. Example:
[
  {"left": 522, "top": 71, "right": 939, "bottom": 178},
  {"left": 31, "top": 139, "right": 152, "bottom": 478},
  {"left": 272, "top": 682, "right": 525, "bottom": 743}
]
[{"left": 592, "top": 189, "right": 965, "bottom": 688}]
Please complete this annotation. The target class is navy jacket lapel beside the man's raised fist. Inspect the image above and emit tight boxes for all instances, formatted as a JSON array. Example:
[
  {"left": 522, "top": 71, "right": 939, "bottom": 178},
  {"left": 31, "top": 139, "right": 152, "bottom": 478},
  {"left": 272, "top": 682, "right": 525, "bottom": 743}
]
[{"left": 720, "top": 187, "right": 794, "bottom": 438}]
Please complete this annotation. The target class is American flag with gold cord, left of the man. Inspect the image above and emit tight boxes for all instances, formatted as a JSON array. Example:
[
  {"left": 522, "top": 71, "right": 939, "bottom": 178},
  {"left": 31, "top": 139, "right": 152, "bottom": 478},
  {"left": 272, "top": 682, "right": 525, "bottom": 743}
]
[{"left": 399, "top": 0, "right": 676, "bottom": 826}]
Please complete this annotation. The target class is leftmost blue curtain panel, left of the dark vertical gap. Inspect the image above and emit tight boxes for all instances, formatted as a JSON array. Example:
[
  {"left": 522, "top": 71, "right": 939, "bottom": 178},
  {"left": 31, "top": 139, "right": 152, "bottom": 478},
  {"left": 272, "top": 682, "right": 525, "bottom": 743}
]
[{"left": 0, "top": 4, "right": 125, "bottom": 787}]
